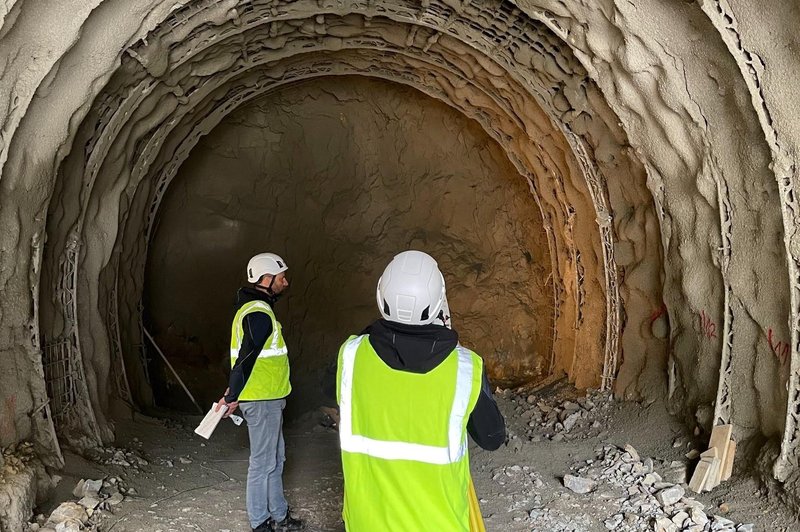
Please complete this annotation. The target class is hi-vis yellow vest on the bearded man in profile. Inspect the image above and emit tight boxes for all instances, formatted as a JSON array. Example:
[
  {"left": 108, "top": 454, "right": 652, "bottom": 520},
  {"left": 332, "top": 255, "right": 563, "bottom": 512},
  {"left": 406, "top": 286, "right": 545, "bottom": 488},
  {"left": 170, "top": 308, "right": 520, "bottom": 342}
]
[{"left": 231, "top": 301, "right": 292, "bottom": 401}]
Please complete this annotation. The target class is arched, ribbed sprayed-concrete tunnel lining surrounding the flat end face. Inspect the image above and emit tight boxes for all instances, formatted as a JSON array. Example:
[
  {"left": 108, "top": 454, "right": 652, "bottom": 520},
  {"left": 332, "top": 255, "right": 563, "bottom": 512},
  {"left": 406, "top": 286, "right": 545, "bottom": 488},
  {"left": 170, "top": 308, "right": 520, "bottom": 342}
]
[{"left": 0, "top": 0, "right": 800, "bottom": 502}]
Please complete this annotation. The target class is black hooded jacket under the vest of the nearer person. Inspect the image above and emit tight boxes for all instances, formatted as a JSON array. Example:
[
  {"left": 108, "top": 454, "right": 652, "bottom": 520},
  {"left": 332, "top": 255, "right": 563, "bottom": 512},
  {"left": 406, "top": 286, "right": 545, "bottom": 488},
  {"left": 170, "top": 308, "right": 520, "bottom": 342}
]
[{"left": 324, "top": 320, "right": 506, "bottom": 451}]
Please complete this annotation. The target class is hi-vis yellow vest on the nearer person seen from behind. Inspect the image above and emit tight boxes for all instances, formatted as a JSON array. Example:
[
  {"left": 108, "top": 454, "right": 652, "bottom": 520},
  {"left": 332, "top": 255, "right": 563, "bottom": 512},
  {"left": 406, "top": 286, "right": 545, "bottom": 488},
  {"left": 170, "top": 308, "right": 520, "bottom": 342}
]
[{"left": 337, "top": 335, "right": 483, "bottom": 532}]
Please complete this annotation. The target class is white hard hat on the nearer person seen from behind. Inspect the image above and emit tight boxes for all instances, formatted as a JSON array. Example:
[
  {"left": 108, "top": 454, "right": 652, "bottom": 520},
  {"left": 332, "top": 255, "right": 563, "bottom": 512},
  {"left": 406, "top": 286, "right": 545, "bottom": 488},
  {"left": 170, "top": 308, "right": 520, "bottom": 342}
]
[{"left": 377, "top": 250, "right": 445, "bottom": 325}]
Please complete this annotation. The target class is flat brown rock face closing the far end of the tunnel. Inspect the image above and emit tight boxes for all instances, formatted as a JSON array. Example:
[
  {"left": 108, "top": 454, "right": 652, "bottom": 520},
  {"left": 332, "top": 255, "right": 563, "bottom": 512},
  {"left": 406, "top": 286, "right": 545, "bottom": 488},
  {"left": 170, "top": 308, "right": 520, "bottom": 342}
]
[{"left": 144, "top": 76, "right": 554, "bottom": 416}]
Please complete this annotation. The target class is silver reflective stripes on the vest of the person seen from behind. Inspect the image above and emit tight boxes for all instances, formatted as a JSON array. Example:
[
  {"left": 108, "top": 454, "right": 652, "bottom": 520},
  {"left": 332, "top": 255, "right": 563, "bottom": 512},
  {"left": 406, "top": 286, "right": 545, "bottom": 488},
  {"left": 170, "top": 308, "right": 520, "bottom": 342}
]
[{"left": 339, "top": 335, "right": 473, "bottom": 465}]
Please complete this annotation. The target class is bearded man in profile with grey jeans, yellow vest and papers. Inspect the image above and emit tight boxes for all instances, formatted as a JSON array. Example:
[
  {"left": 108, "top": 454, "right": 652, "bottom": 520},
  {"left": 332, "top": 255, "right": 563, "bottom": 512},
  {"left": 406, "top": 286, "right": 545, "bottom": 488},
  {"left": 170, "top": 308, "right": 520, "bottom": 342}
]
[{"left": 217, "top": 253, "right": 304, "bottom": 532}]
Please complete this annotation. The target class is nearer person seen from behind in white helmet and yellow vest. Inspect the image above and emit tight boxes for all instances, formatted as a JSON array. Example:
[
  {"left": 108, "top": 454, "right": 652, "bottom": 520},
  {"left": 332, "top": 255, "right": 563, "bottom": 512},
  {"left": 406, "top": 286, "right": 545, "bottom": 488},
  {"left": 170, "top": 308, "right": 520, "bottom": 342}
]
[{"left": 336, "top": 251, "right": 506, "bottom": 532}]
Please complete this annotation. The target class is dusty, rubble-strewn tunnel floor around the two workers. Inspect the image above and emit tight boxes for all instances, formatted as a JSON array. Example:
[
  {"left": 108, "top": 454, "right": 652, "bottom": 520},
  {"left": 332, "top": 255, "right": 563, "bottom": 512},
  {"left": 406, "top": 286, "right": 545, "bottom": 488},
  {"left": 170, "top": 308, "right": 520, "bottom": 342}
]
[{"left": 29, "top": 383, "right": 797, "bottom": 532}]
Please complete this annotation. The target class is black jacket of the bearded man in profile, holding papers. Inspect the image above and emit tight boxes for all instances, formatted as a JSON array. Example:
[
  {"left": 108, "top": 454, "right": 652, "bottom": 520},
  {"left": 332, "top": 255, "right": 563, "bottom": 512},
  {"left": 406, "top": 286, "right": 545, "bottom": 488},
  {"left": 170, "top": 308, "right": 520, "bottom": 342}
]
[{"left": 225, "top": 286, "right": 277, "bottom": 403}]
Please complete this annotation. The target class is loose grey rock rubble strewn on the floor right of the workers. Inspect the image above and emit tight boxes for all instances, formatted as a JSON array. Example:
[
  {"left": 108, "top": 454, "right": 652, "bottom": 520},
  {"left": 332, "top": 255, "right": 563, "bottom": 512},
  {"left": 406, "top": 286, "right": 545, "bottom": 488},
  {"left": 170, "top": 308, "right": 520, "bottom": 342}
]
[{"left": 476, "top": 385, "right": 764, "bottom": 532}]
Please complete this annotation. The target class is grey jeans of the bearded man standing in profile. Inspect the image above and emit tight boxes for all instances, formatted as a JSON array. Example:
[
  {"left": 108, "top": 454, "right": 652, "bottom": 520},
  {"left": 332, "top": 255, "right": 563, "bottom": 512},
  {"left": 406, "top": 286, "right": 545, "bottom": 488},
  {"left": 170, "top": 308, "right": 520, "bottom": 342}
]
[{"left": 239, "top": 399, "right": 289, "bottom": 528}]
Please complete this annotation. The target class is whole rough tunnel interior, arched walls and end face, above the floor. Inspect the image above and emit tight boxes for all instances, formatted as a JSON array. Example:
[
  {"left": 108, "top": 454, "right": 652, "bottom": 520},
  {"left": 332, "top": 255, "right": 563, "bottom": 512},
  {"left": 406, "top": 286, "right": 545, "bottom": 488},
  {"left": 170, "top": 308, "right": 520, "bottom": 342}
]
[{"left": 0, "top": 0, "right": 800, "bottom": 530}]
